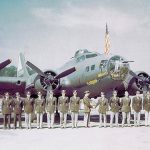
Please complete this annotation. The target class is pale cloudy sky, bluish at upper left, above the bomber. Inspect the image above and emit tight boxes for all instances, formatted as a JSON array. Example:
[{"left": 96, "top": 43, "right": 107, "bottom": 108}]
[{"left": 0, "top": 0, "right": 150, "bottom": 74}]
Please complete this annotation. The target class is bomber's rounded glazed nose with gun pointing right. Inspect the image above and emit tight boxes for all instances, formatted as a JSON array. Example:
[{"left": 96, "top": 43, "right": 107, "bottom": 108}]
[{"left": 108, "top": 56, "right": 129, "bottom": 80}]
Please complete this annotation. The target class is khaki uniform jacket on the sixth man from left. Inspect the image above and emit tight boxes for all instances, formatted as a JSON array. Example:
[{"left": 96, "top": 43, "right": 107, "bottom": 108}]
[{"left": 58, "top": 96, "right": 69, "bottom": 113}]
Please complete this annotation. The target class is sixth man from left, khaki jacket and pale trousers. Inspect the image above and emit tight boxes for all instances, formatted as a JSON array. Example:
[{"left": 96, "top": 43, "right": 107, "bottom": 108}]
[{"left": 58, "top": 90, "right": 69, "bottom": 128}]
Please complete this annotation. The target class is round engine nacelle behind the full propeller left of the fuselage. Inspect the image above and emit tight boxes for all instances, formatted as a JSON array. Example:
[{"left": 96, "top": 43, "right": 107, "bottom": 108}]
[{"left": 34, "top": 70, "right": 60, "bottom": 91}]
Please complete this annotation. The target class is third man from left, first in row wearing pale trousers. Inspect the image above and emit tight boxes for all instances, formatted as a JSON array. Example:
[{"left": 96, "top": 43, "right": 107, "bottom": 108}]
[{"left": 23, "top": 92, "right": 34, "bottom": 129}]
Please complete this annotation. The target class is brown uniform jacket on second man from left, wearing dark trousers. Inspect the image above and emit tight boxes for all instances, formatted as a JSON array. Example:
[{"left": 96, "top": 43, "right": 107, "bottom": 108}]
[{"left": 13, "top": 98, "right": 23, "bottom": 114}]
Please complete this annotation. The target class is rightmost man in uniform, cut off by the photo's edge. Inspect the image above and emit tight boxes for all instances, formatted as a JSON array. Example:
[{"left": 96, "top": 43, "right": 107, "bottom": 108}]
[{"left": 143, "top": 91, "right": 150, "bottom": 126}]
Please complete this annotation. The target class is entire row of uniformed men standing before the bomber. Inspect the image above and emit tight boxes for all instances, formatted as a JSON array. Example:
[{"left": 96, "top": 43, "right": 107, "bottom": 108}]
[{"left": 2, "top": 90, "right": 150, "bottom": 129}]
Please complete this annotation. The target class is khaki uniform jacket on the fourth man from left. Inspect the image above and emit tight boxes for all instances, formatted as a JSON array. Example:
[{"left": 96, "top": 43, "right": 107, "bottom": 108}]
[{"left": 35, "top": 98, "right": 45, "bottom": 113}]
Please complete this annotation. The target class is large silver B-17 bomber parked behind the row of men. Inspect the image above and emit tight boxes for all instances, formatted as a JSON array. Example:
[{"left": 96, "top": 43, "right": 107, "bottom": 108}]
[{"left": 0, "top": 49, "right": 150, "bottom": 97}]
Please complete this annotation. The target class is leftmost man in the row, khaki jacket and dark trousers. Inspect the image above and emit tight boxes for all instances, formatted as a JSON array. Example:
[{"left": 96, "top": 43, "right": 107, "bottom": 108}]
[{"left": 2, "top": 92, "right": 13, "bottom": 129}]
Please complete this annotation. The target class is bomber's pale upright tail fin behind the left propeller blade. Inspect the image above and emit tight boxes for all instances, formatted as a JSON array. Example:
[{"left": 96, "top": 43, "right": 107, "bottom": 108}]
[{"left": 17, "top": 53, "right": 30, "bottom": 78}]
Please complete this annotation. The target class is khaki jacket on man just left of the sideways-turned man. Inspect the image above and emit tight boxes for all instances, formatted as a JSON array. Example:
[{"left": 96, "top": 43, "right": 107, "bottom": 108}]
[{"left": 70, "top": 96, "right": 80, "bottom": 112}]
